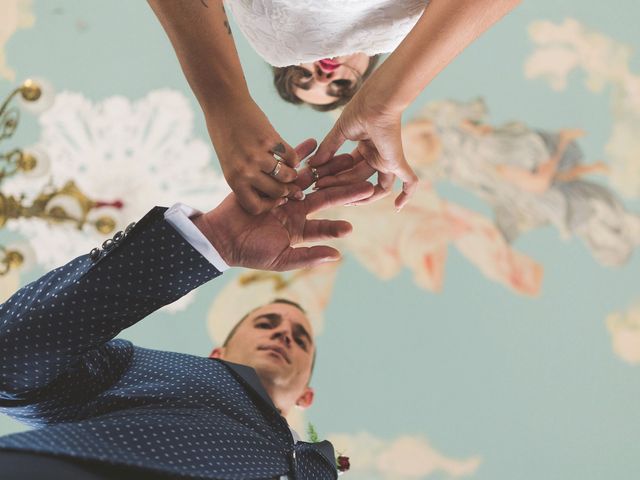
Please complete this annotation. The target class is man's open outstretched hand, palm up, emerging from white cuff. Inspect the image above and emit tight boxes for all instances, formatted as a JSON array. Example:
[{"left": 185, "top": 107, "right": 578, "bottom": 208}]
[{"left": 193, "top": 141, "right": 374, "bottom": 271}]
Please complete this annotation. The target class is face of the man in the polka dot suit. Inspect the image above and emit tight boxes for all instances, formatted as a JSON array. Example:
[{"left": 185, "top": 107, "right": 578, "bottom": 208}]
[{"left": 211, "top": 303, "right": 315, "bottom": 402}]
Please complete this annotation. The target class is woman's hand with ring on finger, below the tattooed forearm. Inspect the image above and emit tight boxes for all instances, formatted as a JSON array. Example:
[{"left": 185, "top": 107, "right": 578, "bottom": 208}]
[{"left": 206, "top": 99, "right": 304, "bottom": 215}]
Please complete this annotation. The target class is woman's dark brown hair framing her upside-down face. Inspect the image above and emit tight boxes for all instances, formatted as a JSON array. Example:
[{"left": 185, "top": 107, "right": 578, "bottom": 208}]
[{"left": 271, "top": 55, "right": 380, "bottom": 112}]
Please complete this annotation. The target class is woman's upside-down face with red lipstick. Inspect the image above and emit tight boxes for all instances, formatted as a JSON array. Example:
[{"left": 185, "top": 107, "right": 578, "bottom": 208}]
[{"left": 293, "top": 53, "right": 369, "bottom": 105}]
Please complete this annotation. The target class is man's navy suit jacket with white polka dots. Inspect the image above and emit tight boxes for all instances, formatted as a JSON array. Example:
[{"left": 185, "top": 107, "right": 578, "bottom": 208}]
[{"left": 0, "top": 207, "right": 337, "bottom": 480}]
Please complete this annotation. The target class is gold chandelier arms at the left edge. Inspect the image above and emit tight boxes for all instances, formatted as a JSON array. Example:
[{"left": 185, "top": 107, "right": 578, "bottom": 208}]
[{"left": 0, "top": 79, "right": 123, "bottom": 275}]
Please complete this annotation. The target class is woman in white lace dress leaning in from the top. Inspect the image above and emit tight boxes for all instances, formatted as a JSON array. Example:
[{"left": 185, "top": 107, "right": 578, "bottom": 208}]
[{"left": 149, "top": 0, "right": 519, "bottom": 214}]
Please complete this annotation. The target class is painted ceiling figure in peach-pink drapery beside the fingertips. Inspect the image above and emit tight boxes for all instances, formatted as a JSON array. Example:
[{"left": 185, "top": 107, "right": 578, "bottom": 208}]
[{"left": 334, "top": 185, "right": 543, "bottom": 296}]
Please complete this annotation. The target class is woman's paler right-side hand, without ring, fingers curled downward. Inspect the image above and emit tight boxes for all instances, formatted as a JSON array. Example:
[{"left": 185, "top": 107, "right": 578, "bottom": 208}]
[{"left": 309, "top": 84, "right": 418, "bottom": 209}]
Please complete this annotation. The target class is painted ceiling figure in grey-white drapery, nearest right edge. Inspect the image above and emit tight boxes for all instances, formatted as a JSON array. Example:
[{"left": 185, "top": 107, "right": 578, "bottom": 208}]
[{"left": 403, "top": 100, "right": 640, "bottom": 266}]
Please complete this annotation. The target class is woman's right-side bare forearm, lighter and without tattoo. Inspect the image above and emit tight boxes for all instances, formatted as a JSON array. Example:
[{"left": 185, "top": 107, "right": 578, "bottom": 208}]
[{"left": 367, "top": 0, "right": 520, "bottom": 110}]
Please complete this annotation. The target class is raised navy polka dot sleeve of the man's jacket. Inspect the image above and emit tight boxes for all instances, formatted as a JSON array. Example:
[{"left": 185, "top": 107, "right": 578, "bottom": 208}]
[{"left": 0, "top": 207, "right": 220, "bottom": 406}]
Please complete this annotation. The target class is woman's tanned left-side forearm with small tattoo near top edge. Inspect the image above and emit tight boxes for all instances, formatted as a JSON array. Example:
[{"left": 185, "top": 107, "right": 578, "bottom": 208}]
[{"left": 148, "top": 0, "right": 249, "bottom": 120}]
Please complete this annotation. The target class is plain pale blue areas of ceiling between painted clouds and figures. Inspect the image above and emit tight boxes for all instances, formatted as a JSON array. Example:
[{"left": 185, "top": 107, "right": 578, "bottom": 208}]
[{"left": 0, "top": 0, "right": 640, "bottom": 480}]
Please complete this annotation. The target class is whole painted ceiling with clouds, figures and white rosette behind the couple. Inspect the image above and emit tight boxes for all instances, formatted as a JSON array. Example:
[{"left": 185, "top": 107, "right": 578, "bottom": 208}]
[{"left": 0, "top": 0, "right": 640, "bottom": 480}]
